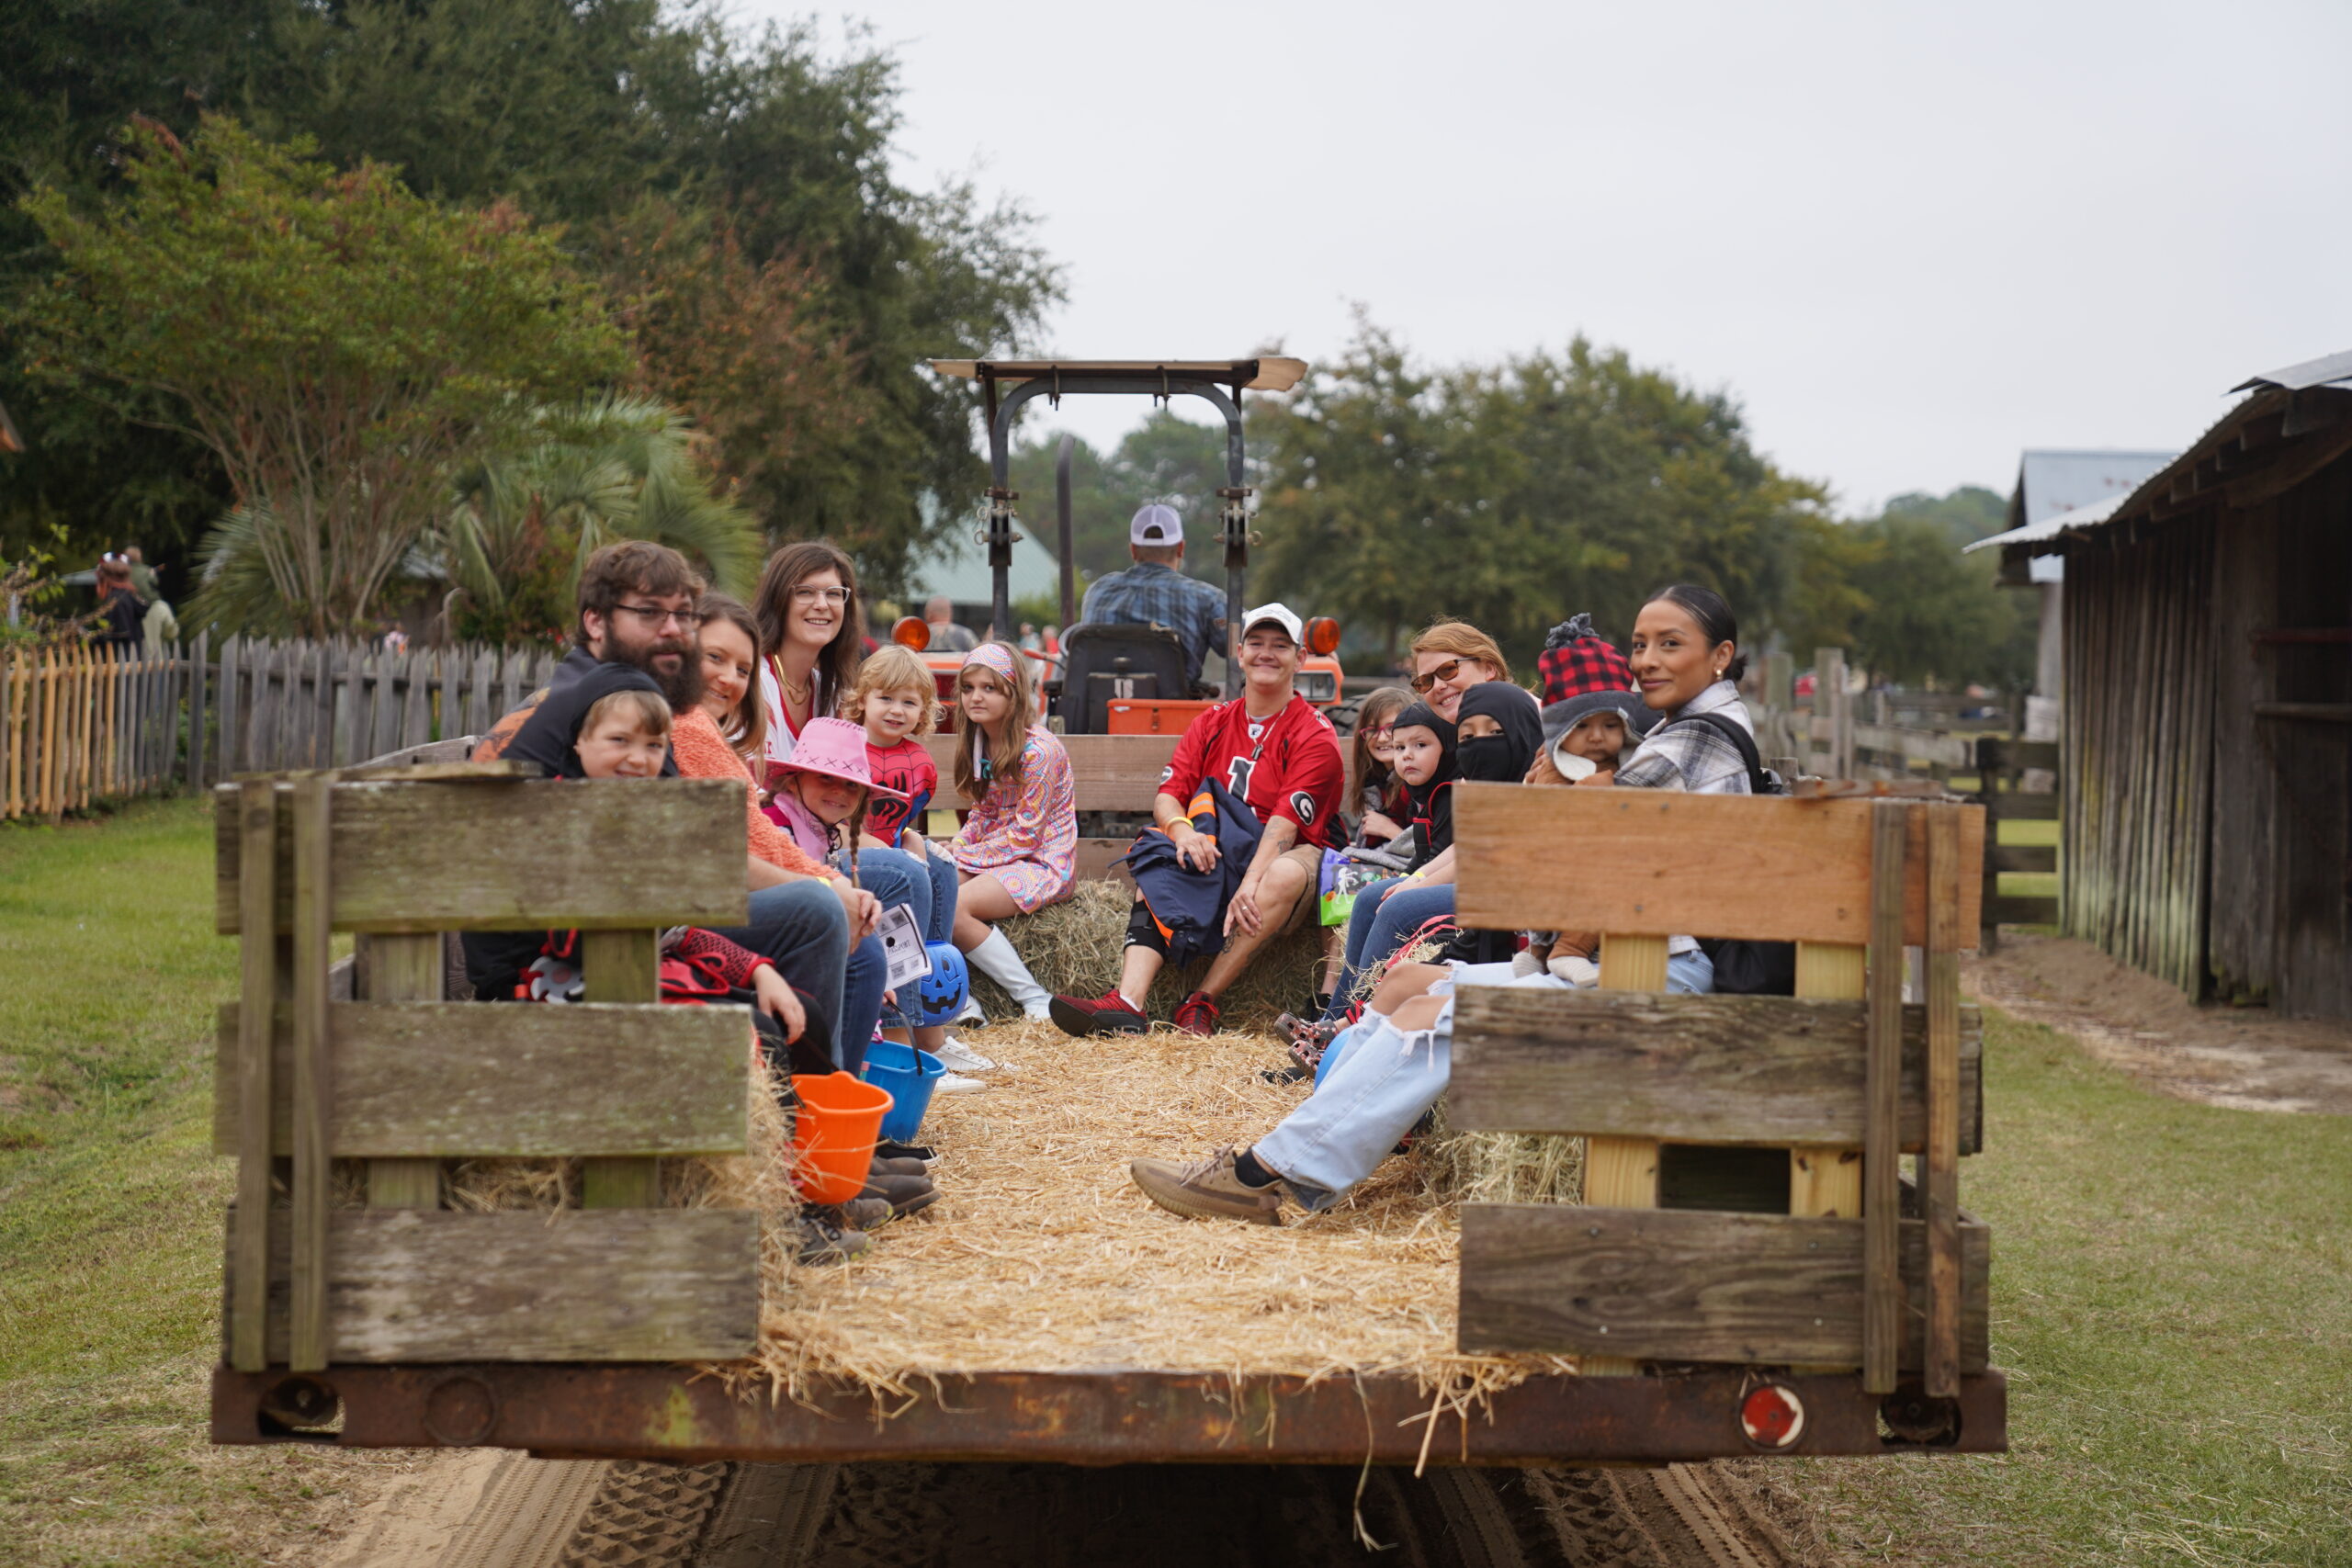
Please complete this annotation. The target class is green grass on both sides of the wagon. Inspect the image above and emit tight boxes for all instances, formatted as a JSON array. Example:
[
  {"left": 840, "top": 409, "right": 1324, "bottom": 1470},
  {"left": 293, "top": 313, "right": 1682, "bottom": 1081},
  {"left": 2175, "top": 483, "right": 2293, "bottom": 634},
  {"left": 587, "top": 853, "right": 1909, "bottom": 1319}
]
[{"left": 0, "top": 802, "right": 2352, "bottom": 1568}]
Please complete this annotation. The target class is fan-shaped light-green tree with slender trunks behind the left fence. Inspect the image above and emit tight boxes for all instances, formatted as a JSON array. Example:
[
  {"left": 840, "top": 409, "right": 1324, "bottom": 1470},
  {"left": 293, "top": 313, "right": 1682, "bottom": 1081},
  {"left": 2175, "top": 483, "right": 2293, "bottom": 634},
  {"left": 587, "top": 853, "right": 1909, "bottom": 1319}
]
[{"left": 18, "top": 118, "right": 626, "bottom": 635}]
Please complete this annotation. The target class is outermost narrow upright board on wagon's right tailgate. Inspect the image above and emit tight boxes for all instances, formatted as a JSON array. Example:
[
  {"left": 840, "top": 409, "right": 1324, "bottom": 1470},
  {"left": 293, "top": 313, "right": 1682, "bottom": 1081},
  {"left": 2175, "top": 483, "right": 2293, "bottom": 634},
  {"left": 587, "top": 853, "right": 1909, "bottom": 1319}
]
[{"left": 1919, "top": 807, "right": 1969, "bottom": 1399}]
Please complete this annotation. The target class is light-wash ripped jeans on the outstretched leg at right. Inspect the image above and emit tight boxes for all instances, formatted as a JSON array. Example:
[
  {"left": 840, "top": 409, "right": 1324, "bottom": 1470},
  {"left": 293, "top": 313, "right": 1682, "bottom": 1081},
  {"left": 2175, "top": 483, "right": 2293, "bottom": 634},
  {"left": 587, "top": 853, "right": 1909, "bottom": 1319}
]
[{"left": 1251, "top": 952, "right": 1714, "bottom": 1208}]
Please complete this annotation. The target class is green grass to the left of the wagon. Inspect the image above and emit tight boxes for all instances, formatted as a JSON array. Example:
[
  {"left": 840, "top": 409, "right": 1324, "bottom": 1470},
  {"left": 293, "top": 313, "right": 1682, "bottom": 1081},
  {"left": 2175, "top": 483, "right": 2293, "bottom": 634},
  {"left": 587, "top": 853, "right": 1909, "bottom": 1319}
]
[{"left": 0, "top": 802, "right": 360, "bottom": 1568}]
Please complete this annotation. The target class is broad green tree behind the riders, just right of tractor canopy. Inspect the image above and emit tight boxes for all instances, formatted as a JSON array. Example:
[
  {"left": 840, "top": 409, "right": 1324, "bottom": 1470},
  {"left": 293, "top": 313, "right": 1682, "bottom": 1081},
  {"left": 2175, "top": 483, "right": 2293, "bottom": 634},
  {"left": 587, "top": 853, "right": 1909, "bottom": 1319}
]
[{"left": 1253, "top": 322, "right": 1827, "bottom": 663}]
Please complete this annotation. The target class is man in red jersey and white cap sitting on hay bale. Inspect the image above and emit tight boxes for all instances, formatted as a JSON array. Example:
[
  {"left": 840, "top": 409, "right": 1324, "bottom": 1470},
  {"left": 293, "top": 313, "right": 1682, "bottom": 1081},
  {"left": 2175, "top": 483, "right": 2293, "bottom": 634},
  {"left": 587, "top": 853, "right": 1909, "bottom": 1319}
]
[{"left": 1051, "top": 606, "right": 1345, "bottom": 1034}]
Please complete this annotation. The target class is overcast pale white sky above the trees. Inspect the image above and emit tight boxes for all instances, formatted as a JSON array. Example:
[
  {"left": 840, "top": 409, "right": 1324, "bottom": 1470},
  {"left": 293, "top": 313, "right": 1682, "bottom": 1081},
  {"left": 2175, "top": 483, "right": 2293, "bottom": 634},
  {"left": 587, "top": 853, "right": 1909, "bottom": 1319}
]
[{"left": 739, "top": 0, "right": 2352, "bottom": 510}]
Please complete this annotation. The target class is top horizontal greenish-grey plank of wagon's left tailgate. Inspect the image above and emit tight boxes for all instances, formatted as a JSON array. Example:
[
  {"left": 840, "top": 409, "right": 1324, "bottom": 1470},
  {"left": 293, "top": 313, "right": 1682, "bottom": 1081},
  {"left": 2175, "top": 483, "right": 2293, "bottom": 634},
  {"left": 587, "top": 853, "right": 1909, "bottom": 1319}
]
[{"left": 217, "top": 778, "right": 748, "bottom": 933}]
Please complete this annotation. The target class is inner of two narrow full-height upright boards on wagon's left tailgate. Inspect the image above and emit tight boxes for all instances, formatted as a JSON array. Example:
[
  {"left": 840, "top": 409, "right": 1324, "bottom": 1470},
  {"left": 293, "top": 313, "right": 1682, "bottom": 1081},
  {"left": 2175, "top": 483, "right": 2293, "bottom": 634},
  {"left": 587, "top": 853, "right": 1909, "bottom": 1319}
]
[{"left": 287, "top": 778, "right": 334, "bottom": 1373}]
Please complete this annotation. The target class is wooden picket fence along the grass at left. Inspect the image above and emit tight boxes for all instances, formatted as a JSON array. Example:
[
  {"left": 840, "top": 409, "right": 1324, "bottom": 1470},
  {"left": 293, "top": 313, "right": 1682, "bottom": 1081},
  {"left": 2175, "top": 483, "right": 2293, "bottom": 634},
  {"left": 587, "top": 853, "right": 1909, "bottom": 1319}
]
[{"left": 0, "top": 632, "right": 562, "bottom": 820}]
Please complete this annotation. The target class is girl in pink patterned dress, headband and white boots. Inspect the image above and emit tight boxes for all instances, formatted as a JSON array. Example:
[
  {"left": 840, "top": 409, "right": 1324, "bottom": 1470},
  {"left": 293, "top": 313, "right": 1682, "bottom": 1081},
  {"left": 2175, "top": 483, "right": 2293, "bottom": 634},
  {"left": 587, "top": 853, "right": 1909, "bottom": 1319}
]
[{"left": 948, "top": 642, "right": 1077, "bottom": 1021}]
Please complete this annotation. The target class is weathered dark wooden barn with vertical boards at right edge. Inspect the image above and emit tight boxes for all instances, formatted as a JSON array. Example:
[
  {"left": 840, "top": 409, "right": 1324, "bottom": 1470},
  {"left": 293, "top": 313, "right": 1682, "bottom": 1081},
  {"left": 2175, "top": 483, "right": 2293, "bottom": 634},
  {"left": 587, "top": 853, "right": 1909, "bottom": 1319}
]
[{"left": 2008, "top": 353, "right": 2352, "bottom": 1018}]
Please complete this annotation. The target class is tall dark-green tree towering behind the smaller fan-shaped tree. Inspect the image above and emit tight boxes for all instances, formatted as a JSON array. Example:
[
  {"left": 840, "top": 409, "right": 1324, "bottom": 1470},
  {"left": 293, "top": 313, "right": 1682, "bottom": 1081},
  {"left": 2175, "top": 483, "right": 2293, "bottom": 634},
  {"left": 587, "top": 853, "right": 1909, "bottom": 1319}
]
[{"left": 0, "top": 0, "right": 1058, "bottom": 588}]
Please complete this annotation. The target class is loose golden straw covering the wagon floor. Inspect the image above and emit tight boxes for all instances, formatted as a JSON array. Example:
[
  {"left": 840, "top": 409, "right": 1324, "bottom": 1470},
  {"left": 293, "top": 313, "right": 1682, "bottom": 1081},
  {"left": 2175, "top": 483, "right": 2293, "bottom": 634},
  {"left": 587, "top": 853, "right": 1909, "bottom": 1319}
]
[{"left": 437, "top": 1025, "right": 1578, "bottom": 1404}]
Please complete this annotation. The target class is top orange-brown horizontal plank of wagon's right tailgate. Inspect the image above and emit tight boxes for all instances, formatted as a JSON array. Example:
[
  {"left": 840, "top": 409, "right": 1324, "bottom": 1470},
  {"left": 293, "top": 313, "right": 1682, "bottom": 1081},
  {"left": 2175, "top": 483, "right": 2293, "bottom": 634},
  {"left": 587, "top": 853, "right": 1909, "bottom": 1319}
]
[{"left": 1453, "top": 783, "right": 1985, "bottom": 945}]
